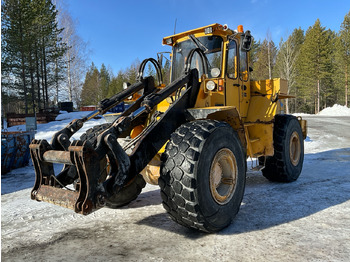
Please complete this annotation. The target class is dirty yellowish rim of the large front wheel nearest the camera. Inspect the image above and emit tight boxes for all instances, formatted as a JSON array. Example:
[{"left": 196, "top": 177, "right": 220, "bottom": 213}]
[{"left": 210, "top": 148, "right": 237, "bottom": 205}]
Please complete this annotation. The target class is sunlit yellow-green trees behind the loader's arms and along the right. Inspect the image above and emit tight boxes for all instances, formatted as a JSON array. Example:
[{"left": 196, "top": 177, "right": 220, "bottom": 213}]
[{"left": 81, "top": 12, "right": 350, "bottom": 113}]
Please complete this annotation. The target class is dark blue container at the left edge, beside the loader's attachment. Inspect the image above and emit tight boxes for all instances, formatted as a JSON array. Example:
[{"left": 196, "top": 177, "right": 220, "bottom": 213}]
[{"left": 1, "top": 132, "right": 34, "bottom": 174}]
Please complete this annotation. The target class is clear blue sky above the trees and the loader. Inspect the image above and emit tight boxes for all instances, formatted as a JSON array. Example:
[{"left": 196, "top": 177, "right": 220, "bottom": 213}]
[{"left": 66, "top": 0, "right": 350, "bottom": 74}]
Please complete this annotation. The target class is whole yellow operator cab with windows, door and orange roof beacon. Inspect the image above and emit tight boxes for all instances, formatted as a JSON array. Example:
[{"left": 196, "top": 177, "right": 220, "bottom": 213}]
[{"left": 163, "top": 24, "right": 251, "bottom": 114}]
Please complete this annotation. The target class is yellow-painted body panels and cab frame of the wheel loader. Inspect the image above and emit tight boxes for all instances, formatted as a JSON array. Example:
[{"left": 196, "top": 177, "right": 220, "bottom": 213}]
[{"left": 152, "top": 24, "right": 306, "bottom": 164}]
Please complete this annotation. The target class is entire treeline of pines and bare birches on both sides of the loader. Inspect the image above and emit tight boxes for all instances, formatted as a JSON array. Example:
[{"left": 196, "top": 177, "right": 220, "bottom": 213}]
[{"left": 1, "top": 0, "right": 350, "bottom": 113}]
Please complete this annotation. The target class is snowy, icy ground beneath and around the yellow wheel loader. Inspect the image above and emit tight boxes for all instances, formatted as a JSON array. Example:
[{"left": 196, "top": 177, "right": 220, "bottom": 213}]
[{"left": 1, "top": 106, "right": 350, "bottom": 261}]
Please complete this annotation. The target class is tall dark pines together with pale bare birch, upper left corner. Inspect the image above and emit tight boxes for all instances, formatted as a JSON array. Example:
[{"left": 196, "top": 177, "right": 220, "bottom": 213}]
[{"left": 1, "top": 0, "right": 87, "bottom": 116}]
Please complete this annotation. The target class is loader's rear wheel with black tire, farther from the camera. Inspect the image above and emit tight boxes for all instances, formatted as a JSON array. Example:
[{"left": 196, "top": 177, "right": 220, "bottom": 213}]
[{"left": 259, "top": 115, "right": 304, "bottom": 183}]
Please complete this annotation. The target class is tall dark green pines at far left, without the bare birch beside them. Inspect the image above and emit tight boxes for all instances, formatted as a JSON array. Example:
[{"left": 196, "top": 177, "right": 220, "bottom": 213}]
[{"left": 1, "top": 0, "right": 66, "bottom": 113}]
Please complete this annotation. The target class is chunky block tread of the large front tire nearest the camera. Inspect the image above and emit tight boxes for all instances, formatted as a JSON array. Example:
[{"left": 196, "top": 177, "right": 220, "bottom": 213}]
[{"left": 159, "top": 120, "right": 225, "bottom": 232}]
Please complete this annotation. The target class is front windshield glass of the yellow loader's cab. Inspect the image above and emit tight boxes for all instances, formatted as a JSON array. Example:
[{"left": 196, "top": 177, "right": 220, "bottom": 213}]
[{"left": 172, "top": 36, "right": 222, "bottom": 81}]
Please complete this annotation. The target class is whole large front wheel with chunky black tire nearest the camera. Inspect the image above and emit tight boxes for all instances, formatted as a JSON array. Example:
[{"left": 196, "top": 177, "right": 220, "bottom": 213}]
[{"left": 159, "top": 120, "right": 246, "bottom": 232}]
